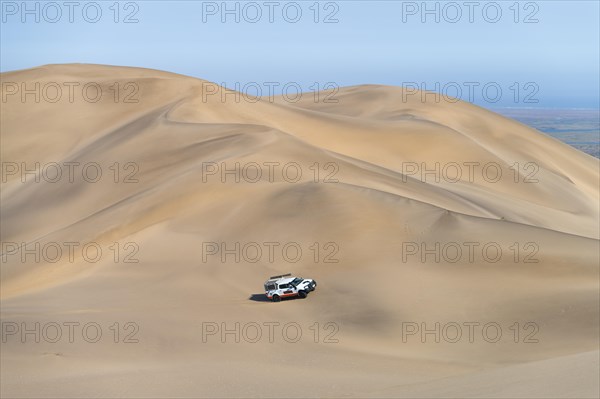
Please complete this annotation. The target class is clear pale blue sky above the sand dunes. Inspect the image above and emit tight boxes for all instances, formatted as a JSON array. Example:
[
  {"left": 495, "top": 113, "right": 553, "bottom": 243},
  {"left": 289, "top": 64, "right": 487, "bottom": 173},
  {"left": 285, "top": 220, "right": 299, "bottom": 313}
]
[{"left": 0, "top": 0, "right": 600, "bottom": 108}]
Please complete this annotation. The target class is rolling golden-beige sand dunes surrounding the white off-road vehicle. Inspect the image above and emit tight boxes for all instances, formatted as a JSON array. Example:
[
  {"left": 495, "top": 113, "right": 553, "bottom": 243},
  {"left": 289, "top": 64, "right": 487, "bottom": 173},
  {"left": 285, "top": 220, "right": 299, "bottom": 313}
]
[{"left": 0, "top": 65, "right": 600, "bottom": 397}]
